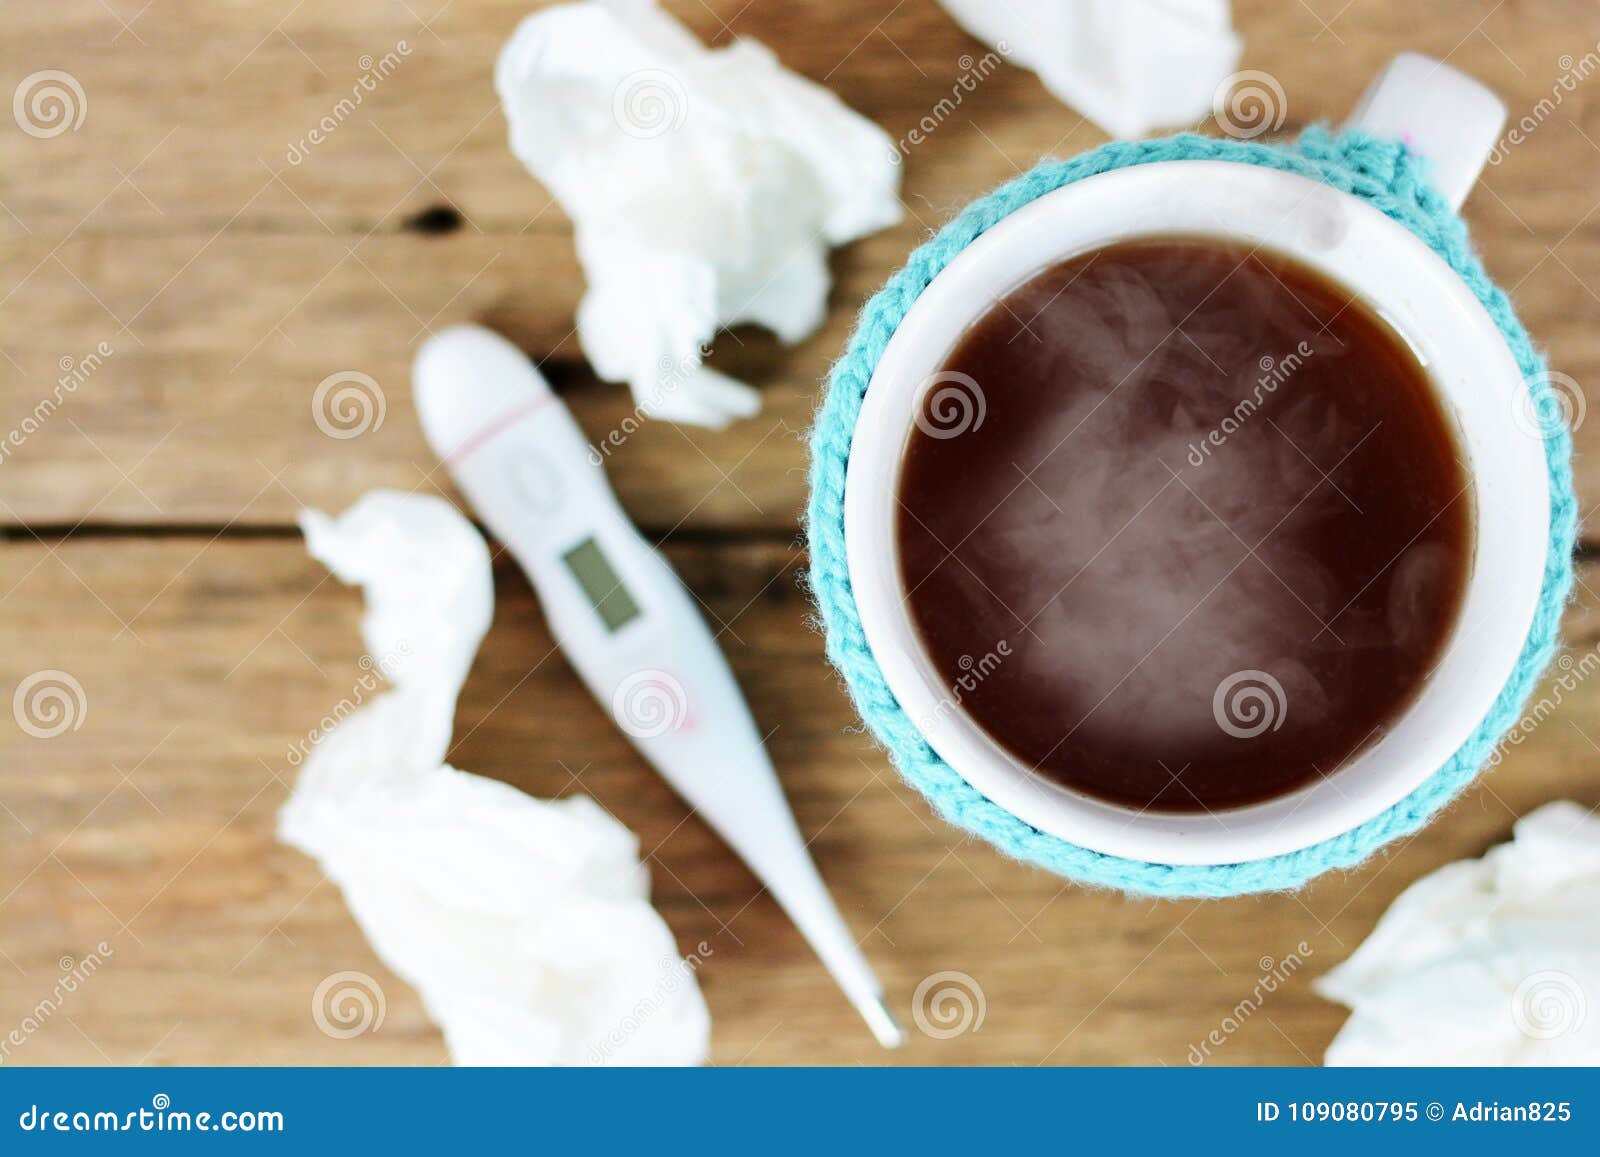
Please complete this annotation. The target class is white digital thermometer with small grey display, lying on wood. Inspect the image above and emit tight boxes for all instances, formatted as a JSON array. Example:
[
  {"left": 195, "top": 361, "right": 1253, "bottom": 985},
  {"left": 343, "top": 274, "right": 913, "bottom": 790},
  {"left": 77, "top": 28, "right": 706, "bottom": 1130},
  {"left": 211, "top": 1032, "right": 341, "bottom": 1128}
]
[{"left": 414, "top": 325, "right": 906, "bottom": 1048}]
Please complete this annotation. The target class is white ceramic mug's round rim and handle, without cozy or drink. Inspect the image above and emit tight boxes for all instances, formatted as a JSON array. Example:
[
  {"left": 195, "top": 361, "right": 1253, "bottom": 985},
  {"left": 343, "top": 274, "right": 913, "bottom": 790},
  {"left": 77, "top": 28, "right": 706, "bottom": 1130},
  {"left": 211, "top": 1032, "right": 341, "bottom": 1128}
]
[{"left": 845, "top": 54, "right": 1550, "bottom": 864}]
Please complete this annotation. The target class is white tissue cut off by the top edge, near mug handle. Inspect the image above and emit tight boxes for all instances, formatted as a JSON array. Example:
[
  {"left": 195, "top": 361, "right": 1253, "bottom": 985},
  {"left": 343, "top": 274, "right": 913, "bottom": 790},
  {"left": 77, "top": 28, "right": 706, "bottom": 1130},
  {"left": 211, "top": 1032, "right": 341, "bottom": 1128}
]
[{"left": 939, "top": 0, "right": 1242, "bottom": 139}]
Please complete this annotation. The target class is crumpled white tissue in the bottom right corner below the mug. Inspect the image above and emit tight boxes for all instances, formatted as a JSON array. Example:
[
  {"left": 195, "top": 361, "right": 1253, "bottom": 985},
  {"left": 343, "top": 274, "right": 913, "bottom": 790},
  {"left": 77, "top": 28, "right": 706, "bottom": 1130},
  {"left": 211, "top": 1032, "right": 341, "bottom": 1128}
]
[{"left": 1315, "top": 803, "right": 1600, "bottom": 1066}]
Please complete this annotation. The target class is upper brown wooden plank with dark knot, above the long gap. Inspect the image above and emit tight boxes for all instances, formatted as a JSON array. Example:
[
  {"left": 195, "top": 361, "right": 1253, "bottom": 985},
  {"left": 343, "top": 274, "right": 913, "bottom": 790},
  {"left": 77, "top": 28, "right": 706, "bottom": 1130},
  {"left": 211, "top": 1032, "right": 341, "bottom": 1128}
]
[{"left": 0, "top": 0, "right": 1600, "bottom": 531}]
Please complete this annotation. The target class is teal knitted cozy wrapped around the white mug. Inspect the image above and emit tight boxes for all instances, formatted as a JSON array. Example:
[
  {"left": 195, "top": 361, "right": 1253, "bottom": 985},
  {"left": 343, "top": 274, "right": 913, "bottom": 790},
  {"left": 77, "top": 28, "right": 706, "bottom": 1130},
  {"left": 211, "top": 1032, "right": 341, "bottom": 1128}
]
[{"left": 806, "top": 126, "right": 1578, "bottom": 898}]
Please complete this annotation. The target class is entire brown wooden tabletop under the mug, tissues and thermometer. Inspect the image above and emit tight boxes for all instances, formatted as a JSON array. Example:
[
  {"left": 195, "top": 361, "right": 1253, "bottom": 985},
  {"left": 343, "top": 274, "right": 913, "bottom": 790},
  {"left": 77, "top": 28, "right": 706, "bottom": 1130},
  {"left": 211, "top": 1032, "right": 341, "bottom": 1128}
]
[{"left": 0, "top": 0, "right": 1600, "bottom": 1064}]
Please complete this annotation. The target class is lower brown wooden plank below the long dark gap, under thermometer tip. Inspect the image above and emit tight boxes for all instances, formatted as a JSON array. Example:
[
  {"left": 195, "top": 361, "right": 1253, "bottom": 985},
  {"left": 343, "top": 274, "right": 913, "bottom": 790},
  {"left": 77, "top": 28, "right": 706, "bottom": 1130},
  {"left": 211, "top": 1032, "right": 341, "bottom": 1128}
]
[{"left": 0, "top": 534, "right": 1600, "bottom": 1064}]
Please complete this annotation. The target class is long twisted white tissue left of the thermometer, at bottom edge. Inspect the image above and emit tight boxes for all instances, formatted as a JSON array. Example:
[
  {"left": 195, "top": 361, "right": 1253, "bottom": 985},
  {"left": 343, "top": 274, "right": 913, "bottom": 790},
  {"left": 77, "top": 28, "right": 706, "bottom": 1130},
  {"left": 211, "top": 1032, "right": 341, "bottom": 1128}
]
[{"left": 278, "top": 491, "right": 710, "bottom": 1064}]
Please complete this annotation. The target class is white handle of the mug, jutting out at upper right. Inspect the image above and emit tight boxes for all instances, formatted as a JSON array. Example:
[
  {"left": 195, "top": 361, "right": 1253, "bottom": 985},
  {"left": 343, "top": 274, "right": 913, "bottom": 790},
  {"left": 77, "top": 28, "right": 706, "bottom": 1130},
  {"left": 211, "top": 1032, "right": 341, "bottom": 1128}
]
[{"left": 1346, "top": 53, "right": 1506, "bottom": 210}]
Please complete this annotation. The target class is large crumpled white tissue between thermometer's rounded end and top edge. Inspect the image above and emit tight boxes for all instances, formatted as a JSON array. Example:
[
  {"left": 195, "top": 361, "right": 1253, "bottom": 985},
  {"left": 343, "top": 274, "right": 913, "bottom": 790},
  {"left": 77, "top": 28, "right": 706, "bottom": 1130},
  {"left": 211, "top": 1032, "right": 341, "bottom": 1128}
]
[{"left": 494, "top": 0, "right": 901, "bottom": 427}]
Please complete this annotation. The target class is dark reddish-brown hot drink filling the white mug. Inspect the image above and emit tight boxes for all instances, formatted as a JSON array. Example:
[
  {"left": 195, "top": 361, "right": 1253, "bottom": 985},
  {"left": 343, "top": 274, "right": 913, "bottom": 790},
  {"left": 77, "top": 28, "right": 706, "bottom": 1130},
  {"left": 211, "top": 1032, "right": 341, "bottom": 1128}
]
[{"left": 898, "top": 238, "right": 1474, "bottom": 811}]
